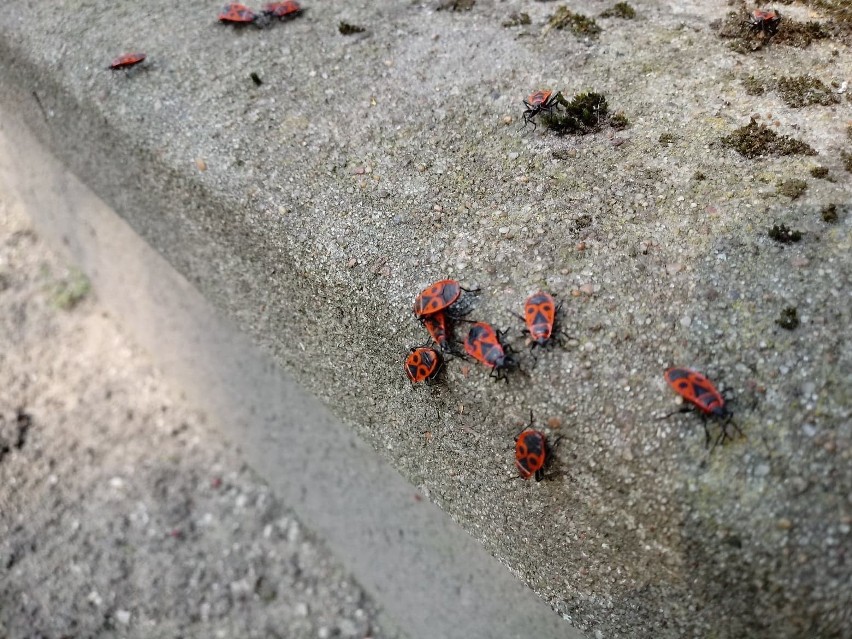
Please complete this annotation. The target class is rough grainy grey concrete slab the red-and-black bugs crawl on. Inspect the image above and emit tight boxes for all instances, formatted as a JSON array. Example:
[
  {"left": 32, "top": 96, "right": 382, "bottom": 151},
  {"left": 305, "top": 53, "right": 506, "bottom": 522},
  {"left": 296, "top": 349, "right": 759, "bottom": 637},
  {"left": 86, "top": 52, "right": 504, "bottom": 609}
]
[{"left": 0, "top": 0, "right": 852, "bottom": 637}]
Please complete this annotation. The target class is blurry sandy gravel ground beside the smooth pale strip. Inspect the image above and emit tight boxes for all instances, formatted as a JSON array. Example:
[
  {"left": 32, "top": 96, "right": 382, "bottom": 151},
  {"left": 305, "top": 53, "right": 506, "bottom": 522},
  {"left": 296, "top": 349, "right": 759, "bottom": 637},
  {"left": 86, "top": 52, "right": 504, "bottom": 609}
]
[{"left": 0, "top": 199, "right": 395, "bottom": 639}]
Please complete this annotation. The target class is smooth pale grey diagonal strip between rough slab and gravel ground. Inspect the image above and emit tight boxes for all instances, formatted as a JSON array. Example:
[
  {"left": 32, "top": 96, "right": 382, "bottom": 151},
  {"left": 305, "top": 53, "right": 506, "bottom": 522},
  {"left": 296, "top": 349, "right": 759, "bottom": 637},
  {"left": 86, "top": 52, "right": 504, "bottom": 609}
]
[{"left": 0, "top": 113, "right": 581, "bottom": 639}]
